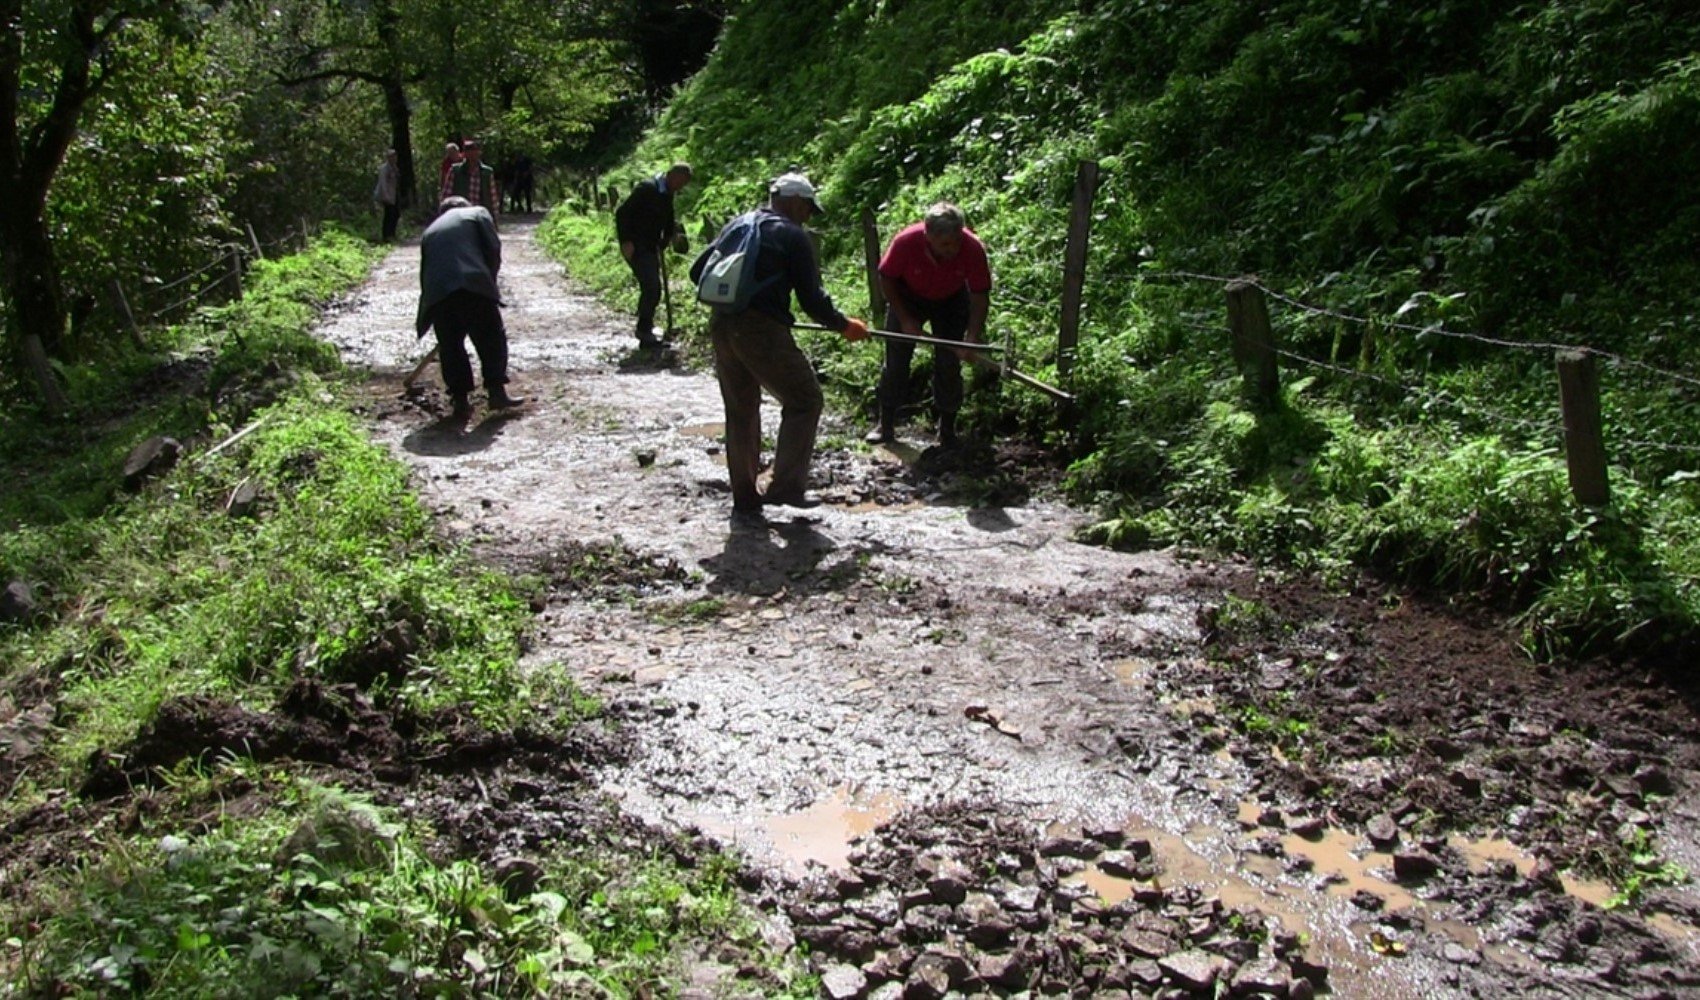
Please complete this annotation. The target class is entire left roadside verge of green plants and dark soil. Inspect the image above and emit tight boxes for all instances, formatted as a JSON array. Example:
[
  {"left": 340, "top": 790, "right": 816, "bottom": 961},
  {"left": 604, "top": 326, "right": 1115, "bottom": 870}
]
[{"left": 0, "top": 231, "right": 808, "bottom": 997}]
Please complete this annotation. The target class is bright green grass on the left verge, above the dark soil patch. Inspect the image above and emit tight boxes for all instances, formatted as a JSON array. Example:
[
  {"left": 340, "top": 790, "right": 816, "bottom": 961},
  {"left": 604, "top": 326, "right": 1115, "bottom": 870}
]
[{"left": 0, "top": 235, "right": 525, "bottom": 764}]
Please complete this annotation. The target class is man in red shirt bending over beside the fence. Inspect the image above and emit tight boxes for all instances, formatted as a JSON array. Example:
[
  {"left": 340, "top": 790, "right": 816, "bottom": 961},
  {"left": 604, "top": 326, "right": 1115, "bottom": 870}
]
[{"left": 867, "top": 201, "right": 991, "bottom": 447}]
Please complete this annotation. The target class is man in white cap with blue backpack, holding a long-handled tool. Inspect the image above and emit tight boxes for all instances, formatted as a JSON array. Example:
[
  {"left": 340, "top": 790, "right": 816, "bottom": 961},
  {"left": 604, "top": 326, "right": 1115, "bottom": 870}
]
[{"left": 690, "top": 173, "right": 867, "bottom": 514}]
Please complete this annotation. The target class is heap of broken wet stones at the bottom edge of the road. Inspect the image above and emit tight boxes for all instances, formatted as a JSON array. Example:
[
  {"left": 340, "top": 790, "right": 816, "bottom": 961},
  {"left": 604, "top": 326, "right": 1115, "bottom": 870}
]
[{"left": 785, "top": 804, "right": 1328, "bottom": 1000}]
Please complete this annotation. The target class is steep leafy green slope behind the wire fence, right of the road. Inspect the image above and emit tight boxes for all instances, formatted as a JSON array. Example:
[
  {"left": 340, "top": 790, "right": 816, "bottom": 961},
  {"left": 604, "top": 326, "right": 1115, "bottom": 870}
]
[{"left": 605, "top": 0, "right": 1700, "bottom": 648}]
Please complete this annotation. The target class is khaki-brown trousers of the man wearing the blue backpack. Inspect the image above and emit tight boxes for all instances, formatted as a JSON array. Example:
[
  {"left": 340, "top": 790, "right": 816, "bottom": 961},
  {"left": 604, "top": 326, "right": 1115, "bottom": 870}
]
[{"left": 709, "top": 310, "right": 823, "bottom": 510}]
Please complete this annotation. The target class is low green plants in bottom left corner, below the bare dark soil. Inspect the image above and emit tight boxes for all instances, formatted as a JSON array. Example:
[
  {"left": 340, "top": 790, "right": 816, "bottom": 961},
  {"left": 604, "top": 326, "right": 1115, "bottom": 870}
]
[{"left": 9, "top": 781, "right": 782, "bottom": 997}]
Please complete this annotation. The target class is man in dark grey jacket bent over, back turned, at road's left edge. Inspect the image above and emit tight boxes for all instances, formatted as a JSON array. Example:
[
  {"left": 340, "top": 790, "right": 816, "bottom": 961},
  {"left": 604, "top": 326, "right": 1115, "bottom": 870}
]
[{"left": 415, "top": 196, "right": 525, "bottom": 418}]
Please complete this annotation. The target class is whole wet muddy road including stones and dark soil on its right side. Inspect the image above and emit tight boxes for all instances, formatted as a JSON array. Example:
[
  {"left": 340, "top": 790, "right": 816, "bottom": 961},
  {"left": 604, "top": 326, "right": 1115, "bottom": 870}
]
[{"left": 323, "top": 219, "right": 1700, "bottom": 997}]
